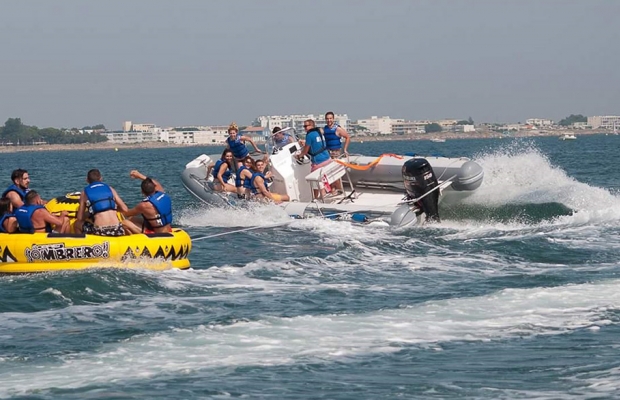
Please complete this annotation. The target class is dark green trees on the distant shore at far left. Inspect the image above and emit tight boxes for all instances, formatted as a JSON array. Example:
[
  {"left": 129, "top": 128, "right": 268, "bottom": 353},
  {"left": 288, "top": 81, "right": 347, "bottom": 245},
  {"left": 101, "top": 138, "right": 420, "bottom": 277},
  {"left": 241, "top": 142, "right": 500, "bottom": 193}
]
[{"left": 0, "top": 118, "right": 108, "bottom": 145}]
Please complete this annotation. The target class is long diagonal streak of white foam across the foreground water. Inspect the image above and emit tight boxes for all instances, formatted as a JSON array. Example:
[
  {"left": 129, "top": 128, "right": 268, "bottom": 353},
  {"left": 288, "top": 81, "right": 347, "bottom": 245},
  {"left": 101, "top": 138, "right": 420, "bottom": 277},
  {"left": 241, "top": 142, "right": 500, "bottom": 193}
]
[{"left": 0, "top": 280, "right": 620, "bottom": 396}]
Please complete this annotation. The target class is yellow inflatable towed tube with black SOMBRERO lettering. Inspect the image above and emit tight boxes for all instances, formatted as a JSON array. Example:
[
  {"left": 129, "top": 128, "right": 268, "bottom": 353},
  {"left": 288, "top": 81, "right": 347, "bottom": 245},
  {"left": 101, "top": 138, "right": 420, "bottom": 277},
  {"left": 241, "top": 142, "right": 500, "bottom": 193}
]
[{"left": 0, "top": 193, "right": 192, "bottom": 273}]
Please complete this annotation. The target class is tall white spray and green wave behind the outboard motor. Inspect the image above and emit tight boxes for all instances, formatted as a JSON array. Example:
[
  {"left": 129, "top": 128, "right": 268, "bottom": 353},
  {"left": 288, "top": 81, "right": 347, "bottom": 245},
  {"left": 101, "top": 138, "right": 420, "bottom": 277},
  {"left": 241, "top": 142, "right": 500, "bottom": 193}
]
[{"left": 452, "top": 143, "right": 620, "bottom": 224}]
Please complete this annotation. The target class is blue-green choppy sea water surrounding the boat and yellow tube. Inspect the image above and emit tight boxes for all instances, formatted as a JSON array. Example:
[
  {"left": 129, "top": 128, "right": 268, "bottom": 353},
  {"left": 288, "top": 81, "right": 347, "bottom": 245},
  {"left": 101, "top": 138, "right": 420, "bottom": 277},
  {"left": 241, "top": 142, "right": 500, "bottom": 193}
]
[{"left": 0, "top": 135, "right": 620, "bottom": 399}]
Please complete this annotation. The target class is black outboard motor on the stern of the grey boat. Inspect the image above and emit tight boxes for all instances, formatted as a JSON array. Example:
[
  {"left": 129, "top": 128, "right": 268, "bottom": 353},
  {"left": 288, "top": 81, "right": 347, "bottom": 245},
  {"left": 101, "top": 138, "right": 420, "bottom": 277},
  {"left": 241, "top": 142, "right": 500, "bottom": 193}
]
[{"left": 402, "top": 158, "right": 439, "bottom": 222}]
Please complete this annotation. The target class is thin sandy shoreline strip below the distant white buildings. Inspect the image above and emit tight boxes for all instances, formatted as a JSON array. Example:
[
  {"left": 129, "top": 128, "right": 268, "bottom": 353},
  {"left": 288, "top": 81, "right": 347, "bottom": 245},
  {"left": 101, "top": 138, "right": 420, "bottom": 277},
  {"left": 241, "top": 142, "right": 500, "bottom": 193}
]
[{"left": 0, "top": 129, "right": 606, "bottom": 153}]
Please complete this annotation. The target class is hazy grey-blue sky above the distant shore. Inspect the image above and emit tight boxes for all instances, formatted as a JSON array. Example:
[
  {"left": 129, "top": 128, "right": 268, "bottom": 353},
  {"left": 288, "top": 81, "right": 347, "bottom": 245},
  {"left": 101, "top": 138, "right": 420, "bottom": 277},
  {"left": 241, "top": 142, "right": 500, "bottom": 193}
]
[{"left": 0, "top": 0, "right": 620, "bottom": 129}]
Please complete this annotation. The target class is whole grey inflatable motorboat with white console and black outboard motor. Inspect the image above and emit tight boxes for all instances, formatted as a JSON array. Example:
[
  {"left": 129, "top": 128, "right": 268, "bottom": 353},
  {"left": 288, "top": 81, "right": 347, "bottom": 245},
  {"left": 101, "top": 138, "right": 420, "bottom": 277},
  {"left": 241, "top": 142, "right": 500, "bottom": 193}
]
[{"left": 181, "top": 130, "right": 484, "bottom": 227}]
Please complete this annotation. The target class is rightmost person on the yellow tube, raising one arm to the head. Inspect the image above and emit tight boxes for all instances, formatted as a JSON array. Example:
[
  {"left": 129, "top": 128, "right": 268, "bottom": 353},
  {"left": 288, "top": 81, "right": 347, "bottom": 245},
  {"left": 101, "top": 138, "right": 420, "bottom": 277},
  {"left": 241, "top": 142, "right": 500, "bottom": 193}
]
[{"left": 123, "top": 170, "right": 172, "bottom": 233}]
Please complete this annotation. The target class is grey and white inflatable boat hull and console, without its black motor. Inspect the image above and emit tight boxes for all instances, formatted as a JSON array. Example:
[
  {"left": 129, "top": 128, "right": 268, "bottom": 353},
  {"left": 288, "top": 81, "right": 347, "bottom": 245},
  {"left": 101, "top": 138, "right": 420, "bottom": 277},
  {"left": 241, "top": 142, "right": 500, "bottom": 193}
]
[{"left": 181, "top": 152, "right": 484, "bottom": 226}]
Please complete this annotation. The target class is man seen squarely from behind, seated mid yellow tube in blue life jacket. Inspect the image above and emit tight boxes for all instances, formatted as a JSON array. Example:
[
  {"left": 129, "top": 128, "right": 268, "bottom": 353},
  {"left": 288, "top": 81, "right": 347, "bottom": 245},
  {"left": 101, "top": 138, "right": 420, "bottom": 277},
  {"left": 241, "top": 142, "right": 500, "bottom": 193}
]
[{"left": 73, "top": 169, "right": 127, "bottom": 236}]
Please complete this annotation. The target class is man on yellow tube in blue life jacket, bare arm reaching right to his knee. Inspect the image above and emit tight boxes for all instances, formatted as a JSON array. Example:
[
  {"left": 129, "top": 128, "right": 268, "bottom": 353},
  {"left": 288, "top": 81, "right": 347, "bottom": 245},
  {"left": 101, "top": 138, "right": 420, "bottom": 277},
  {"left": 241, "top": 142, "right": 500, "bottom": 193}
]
[{"left": 15, "top": 190, "right": 71, "bottom": 233}]
